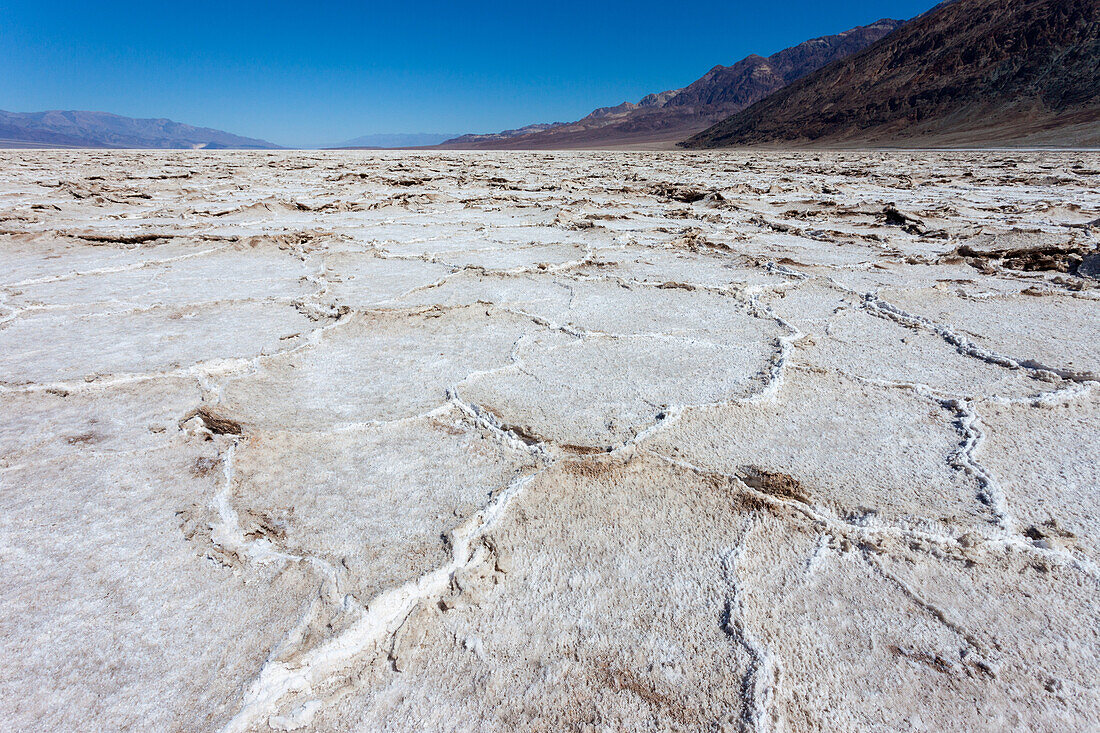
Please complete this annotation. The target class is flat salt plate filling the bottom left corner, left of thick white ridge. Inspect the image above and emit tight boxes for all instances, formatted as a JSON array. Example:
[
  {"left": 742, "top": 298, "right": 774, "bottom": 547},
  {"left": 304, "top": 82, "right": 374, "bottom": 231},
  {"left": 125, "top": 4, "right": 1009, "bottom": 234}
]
[{"left": 0, "top": 380, "right": 316, "bottom": 730}]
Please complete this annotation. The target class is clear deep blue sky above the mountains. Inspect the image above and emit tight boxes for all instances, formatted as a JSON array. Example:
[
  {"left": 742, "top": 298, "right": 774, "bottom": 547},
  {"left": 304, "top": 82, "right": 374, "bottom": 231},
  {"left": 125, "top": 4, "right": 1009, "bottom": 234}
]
[{"left": 0, "top": 0, "right": 935, "bottom": 145}]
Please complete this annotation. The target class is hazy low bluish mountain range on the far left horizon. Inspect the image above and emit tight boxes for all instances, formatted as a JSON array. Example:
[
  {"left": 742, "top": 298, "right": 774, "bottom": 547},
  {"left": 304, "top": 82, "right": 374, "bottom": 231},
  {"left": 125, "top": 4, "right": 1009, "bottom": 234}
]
[{"left": 0, "top": 110, "right": 278, "bottom": 150}]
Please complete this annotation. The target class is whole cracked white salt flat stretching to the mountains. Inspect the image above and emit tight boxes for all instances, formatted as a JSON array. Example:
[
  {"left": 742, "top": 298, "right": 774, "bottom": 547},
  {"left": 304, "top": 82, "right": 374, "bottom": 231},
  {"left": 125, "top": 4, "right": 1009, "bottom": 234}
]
[{"left": 0, "top": 151, "right": 1100, "bottom": 731}]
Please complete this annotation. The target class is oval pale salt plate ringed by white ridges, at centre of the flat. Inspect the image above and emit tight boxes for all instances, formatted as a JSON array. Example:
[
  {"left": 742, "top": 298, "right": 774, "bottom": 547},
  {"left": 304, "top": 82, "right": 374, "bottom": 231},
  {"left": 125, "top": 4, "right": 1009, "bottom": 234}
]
[{"left": 458, "top": 319, "right": 785, "bottom": 452}]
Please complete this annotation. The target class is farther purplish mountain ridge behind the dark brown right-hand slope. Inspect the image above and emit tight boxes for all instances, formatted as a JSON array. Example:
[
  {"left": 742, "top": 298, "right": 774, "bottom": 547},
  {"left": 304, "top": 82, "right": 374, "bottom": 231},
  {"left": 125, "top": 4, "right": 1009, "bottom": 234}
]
[{"left": 440, "top": 20, "right": 901, "bottom": 150}]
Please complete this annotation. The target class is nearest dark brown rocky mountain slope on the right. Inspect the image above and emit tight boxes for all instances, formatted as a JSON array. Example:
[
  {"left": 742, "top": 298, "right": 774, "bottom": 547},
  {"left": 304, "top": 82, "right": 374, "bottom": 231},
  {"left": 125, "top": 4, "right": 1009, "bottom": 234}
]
[{"left": 683, "top": 0, "right": 1100, "bottom": 147}]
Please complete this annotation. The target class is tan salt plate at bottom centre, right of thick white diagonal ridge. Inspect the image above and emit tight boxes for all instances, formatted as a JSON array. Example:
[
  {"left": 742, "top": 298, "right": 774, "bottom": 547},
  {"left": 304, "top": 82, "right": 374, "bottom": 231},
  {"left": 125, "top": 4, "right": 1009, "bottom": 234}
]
[{"left": 330, "top": 458, "right": 770, "bottom": 726}]
